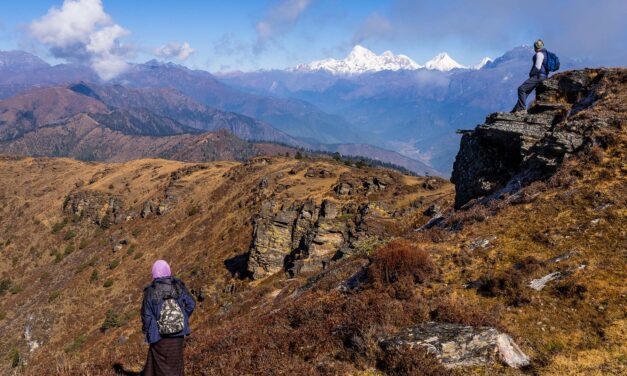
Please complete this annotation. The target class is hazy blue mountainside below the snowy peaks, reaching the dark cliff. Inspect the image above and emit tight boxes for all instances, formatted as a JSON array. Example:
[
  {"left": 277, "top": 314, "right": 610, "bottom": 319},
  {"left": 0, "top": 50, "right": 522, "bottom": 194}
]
[{"left": 220, "top": 46, "right": 582, "bottom": 173}]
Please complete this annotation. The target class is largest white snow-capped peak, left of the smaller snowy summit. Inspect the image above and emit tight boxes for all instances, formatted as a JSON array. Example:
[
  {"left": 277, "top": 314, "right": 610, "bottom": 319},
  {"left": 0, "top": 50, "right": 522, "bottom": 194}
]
[{"left": 294, "top": 45, "right": 422, "bottom": 74}]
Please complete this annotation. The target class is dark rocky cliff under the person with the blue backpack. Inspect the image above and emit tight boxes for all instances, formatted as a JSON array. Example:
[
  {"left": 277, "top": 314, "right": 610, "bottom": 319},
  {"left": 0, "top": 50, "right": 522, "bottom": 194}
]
[{"left": 451, "top": 69, "right": 627, "bottom": 208}]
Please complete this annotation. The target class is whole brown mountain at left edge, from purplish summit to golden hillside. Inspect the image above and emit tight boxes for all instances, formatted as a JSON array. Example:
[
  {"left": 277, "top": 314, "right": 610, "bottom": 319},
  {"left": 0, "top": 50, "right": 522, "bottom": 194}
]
[{"left": 0, "top": 87, "right": 259, "bottom": 161}]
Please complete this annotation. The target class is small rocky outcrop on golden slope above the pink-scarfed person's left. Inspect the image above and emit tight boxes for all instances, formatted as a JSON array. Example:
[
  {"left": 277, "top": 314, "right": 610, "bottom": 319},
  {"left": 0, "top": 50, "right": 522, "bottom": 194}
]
[{"left": 63, "top": 190, "right": 125, "bottom": 226}]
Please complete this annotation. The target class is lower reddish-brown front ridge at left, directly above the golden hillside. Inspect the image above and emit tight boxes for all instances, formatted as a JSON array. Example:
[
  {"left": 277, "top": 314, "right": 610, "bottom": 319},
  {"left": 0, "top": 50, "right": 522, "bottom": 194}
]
[{"left": 0, "top": 114, "right": 258, "bottom": 162}]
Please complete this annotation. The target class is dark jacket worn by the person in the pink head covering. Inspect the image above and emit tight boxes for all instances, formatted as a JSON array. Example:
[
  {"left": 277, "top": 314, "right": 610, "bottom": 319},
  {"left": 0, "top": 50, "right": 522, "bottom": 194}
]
[{"left": 141, "top": 277, "right": 196, "bottom": 343}]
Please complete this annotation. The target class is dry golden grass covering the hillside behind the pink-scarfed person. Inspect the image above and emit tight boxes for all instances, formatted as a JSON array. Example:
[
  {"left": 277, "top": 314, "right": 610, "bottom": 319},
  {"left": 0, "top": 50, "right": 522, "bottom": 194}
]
[{"left": 0, "top": 158, "right": 452, "bottom": 374}]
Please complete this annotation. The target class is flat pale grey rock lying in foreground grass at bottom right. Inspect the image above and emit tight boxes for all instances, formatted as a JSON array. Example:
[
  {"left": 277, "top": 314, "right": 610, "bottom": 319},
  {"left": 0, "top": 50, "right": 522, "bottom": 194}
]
[{"left": 380, "top": 322, "right": 530, "bottom": 368}]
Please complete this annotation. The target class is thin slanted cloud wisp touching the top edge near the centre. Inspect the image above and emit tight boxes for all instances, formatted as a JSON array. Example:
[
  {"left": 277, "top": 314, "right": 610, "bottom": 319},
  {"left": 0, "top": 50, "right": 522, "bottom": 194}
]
[{"left": 255, "top": 0, "right": 314, "bottom": 52}]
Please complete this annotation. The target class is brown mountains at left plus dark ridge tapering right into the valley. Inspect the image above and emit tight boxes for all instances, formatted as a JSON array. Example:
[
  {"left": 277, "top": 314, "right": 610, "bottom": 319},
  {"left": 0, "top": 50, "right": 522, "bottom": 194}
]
[{"left": 0, "top": 82, "right": 439, "bottom": 175}]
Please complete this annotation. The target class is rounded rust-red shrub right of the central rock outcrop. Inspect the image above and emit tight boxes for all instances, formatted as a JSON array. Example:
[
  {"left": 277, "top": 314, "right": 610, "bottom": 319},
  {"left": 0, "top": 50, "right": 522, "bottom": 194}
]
[{"left": 368, "top": 239, "right": 436, "bottom": 285}]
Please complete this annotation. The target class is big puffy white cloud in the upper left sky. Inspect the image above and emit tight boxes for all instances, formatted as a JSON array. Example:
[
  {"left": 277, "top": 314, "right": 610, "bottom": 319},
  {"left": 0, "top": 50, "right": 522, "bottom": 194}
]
[{"left": 29, "top": 0, "right": 130, "bottom": 80}]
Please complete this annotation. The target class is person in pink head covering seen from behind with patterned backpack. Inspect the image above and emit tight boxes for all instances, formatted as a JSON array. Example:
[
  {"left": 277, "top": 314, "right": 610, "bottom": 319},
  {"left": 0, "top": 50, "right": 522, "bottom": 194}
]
[{"left": 141, "top": 260, "right": 196, "bottom": 376}]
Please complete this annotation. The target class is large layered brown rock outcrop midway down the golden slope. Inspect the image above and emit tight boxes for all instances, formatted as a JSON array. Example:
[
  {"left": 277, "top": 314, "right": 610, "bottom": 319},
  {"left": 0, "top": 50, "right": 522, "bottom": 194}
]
[{"left": 247, "top": 167, "right": 442, "bottom": 279}]
